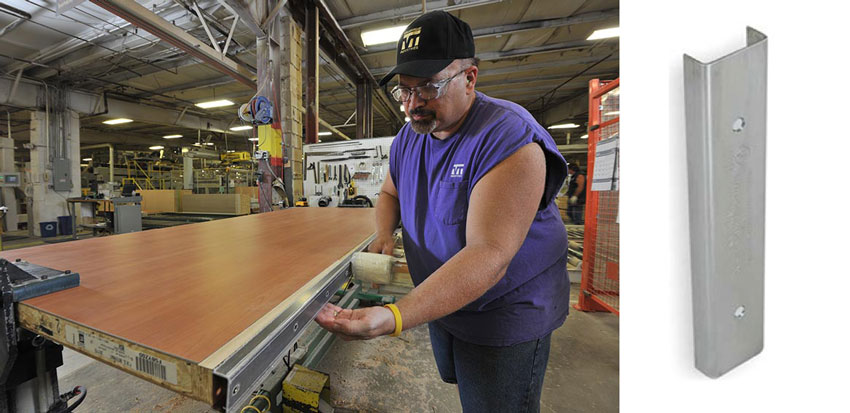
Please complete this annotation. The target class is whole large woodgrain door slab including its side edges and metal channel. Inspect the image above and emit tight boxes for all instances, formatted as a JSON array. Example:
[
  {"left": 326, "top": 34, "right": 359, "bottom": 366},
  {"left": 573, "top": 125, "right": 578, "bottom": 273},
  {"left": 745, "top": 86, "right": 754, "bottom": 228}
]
[{"left": 0, "top": 208, "right": 374, "bottom": 411}]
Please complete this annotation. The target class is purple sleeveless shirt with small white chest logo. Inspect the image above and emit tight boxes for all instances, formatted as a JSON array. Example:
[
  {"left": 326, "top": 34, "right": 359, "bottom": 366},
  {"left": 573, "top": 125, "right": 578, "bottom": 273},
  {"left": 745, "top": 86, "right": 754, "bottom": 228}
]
[{"left": 390, "top": 92, "right": 570, "bottom": 346}]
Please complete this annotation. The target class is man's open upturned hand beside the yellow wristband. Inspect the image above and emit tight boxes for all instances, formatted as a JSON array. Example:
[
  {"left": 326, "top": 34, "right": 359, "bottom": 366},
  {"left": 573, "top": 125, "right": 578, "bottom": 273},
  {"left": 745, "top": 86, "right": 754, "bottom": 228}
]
[{"left": 316, "top": 303, "right": 395, "bottom": 341}]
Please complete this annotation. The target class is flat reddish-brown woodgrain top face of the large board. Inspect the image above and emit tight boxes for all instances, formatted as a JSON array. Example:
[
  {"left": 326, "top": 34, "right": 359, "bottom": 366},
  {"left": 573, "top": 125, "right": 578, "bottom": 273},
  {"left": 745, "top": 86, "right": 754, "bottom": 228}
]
[{"left": 0, "top": 208, "right": 374, "bottom": 363}]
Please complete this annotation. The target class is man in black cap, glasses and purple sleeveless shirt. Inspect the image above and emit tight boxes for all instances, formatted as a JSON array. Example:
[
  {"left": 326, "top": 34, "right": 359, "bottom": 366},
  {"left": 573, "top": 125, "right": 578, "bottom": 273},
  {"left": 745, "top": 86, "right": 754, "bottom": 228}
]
[{"left": 317, "top": 11, "right": 569, "bottom": 412}]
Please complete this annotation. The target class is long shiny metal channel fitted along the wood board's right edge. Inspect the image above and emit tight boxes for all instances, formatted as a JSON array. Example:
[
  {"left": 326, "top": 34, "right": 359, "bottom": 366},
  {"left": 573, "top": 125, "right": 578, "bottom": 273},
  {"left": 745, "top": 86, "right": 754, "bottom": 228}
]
[{"left": 213, "top": 235, "right": 375, "bottom": 412}]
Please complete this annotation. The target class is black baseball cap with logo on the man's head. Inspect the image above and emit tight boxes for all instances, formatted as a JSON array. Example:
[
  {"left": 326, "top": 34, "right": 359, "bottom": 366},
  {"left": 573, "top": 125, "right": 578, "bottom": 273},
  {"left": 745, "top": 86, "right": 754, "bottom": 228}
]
[{"left": 379, "top": 11, "right": 475, "bottom": 86}]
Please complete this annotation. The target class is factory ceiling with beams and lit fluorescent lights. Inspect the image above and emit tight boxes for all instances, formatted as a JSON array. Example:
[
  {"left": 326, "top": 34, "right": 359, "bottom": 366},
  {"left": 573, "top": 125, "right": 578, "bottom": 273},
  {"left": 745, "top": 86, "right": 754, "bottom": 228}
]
[{"left": 0, "top": 0, "right": 619, "bottom": 156}]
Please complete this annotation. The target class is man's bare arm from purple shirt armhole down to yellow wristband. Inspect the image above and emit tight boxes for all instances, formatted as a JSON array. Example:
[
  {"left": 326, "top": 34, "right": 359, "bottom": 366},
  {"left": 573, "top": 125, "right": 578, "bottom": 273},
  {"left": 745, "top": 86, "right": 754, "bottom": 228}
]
[{"left": 397, "top": 143, "right": 546, "bottom": 329}]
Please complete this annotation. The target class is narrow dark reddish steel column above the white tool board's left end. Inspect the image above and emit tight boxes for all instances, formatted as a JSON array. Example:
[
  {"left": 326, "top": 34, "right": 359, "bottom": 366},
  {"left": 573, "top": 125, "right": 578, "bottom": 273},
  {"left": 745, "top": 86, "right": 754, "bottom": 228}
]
[{"left": 304, "top": 0, "right": 319, "bottom": 143}]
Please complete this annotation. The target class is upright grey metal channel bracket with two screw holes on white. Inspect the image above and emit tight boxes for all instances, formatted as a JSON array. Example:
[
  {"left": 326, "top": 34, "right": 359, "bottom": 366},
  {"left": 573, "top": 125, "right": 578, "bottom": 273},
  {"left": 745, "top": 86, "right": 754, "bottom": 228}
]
[{"left": 684, "top": 27, "right": 767, "bottom": 378}]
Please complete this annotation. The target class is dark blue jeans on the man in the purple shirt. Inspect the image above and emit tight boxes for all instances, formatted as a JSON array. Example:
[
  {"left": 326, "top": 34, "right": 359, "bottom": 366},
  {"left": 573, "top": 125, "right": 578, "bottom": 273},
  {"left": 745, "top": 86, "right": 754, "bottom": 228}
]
[{"left": 428, "top": 323, "right": 552, "bottom": 413}]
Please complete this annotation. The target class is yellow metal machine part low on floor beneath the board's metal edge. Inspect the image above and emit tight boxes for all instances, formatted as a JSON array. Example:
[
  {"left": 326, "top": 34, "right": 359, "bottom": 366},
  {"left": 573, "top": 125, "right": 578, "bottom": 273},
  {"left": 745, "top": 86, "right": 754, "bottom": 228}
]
[{"left": 283, "top": 364, "right": 330, "bottom": 413}]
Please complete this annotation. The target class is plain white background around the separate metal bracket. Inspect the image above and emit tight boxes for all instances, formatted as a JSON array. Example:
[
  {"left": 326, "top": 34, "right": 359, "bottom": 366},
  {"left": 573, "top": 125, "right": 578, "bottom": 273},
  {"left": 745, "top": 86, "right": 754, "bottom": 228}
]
[{"left": 620, "top": 0, "right": 850, "bottom": 413}]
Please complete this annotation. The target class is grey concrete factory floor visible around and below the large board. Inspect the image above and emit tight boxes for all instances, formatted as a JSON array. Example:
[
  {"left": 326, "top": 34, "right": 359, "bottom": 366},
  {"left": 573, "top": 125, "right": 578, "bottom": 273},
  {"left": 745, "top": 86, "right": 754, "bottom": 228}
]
[{"left": 58, "top": 285, "right": 619, "bottom": 413}]
